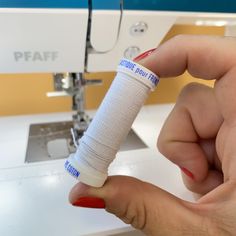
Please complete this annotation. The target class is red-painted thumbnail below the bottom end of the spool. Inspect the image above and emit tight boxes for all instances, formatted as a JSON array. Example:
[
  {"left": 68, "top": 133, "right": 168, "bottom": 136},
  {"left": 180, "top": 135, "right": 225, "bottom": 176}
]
[{"left": 72, "top": 197, "right": 105, "bottom": 208}]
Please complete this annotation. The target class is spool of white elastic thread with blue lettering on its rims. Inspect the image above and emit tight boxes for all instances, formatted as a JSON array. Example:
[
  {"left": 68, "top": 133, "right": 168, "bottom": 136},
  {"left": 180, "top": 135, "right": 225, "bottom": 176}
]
[{"left": 65, "top": 59, "right": 159, "bottom": 187}]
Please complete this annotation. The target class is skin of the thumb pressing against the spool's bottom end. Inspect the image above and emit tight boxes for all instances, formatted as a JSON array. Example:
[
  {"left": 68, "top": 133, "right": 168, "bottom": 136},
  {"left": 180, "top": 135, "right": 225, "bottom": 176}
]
[{"left": 69, "top": 176, "right": 208, "bottom": 235}]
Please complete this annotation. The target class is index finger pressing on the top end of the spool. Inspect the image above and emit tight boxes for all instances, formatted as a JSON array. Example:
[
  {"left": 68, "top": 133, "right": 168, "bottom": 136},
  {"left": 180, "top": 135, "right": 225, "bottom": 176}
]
[{"left": 140, "top": 35, "right": 236, "bottom": 80}]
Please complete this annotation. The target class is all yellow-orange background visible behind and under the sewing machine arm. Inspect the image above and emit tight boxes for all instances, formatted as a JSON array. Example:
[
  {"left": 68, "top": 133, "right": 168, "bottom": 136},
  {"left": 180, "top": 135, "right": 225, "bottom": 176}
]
[{"left": 0, "top": 25, "right": 224, "bottom": 115}]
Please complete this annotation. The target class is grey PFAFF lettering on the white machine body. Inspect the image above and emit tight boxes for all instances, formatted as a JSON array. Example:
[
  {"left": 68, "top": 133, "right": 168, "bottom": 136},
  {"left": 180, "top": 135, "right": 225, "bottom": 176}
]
[{"left": 14, "top": 51, "right": 59, "bottom": 62}]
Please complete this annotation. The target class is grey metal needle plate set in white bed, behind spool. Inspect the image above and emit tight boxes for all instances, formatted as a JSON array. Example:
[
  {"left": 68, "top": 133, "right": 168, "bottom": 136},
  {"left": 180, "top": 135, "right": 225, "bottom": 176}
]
[{"left": 25, "top": 121, "right": 147, "bottom": 163}]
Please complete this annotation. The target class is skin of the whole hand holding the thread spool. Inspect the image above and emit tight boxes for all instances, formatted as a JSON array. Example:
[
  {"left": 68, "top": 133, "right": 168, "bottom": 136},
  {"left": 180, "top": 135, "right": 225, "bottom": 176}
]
[{"left": 69, "top": 36, "right": 236, "bottom": 236}]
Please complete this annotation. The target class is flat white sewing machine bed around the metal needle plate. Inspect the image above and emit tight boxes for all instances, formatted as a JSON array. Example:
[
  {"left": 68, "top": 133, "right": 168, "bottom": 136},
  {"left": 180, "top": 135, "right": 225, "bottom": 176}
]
[{"left": 0, "top": 104, "right": 194, "bottom": 236}]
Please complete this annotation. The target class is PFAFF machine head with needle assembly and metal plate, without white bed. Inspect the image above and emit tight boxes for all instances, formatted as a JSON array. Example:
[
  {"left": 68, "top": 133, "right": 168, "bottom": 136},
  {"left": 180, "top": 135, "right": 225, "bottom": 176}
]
[{"left": 0, "top": 0, "right": 236, "bottom": 162}]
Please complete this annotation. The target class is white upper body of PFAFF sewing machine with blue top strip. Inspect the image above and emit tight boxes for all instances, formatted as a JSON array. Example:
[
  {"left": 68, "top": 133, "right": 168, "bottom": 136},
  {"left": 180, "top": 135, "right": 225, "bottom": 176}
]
[{"left": 0, "top": 0, "right": 236, "bottom": 73}]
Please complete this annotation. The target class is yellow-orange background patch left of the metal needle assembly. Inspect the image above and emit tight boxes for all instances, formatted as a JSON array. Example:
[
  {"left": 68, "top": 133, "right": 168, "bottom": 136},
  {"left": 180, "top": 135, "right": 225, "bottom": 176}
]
[{"left": 0, "top": 74, "right": 71, "bottom": 115}]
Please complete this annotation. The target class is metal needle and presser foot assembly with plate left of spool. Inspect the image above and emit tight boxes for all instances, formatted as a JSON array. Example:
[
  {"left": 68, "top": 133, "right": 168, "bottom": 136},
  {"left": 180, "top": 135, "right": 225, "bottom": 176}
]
[{"left": 25, "top": 73, "right": 101, "bottom": 162}]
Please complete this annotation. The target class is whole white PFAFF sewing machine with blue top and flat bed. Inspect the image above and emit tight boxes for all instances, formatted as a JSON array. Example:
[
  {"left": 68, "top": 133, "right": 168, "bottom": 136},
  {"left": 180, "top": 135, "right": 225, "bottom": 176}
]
[{"left": 0, "top": 0, "right": 236, "bottom": 236}]
